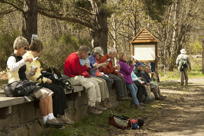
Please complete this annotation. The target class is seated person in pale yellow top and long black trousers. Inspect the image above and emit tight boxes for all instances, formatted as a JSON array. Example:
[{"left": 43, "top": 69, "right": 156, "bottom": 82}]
[{"left": 23, "top": 37, "right": 73, "bottom": 124}]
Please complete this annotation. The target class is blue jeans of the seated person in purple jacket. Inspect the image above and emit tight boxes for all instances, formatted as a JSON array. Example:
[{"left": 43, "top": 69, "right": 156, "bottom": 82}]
[{"left": 127, "top": 83, "right": 139, "bottom": 105}]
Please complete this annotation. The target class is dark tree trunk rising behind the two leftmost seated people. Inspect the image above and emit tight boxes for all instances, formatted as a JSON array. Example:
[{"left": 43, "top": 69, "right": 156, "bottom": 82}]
[{"left": 22, "top": 0, "right": 38, "bottom": 43}]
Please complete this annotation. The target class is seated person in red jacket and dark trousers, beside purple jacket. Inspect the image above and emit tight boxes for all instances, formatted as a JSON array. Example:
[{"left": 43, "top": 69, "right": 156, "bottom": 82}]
[{"left": 99, "top": 48, "right": 128, "bottom": 100}]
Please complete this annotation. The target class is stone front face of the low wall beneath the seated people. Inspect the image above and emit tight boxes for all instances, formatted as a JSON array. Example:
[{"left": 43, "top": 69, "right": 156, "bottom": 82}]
[{"left": 0, "top": 90, "right": 117, "bottom": 136}]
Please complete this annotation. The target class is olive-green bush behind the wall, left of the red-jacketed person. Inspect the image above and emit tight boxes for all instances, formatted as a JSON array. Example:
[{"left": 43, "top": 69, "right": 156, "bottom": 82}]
[{"left": 42, "top": 34, "right": 90, "bottom": 70}]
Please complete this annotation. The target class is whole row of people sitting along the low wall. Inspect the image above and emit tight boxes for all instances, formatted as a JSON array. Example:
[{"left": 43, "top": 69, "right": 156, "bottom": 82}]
[{"left": 7, "top": 36, "right": 165, "bottom": 127}]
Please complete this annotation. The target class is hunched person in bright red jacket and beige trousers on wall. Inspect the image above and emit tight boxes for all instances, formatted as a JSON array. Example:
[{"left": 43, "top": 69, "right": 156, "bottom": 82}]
[{"left": 64, "top": 46, "right": 102, "bottom": 114}]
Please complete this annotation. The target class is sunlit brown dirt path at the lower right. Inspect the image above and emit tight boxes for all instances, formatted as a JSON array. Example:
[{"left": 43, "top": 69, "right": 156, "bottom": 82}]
[{"left": 120, "top": 79, "right": 204, "bottom": 136}]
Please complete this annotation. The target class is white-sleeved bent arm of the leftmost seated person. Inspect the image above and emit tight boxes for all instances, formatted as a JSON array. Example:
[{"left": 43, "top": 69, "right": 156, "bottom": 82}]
[{"left": 7, "top": 56, "right": 25, "bottom": 71}]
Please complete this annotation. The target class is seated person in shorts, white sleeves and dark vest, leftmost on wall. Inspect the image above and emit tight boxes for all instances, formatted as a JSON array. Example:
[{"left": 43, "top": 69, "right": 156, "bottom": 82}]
[{"left": 7, "top": 36, "right": 62, "bottom": 127}]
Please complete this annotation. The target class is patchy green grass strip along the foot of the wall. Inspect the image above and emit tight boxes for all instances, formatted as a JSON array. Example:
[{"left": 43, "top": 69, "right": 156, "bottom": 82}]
[{"left": 43, "top": 101, "right": 164, "bottom": 136}]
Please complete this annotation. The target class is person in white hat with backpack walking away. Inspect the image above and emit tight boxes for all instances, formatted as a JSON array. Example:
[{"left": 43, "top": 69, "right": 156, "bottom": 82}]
[{"left": 176, "top": 49, "right": 191, "bottom": 86}]
